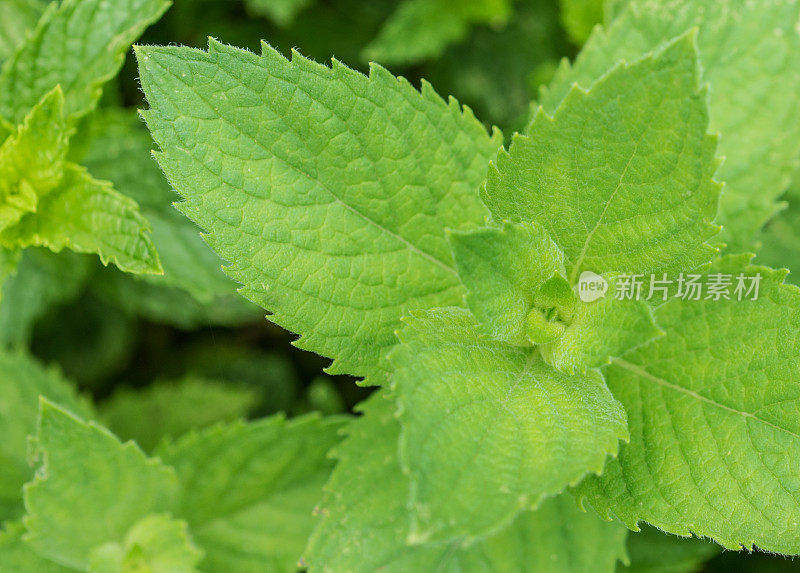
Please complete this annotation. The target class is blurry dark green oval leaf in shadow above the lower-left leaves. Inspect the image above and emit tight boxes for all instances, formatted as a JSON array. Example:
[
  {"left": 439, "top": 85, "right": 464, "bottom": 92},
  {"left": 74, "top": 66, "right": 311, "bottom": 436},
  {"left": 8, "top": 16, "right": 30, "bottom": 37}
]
[{"left": 101, "top": 377, "right": 260, "bottom": 451}]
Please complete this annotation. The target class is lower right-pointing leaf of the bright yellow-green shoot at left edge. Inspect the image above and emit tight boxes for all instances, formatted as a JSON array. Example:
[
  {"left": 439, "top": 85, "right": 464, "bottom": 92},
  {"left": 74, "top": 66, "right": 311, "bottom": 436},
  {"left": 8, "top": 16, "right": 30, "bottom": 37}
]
[{"left": 0, "top": 163, "right": 163, "bottom": 273}]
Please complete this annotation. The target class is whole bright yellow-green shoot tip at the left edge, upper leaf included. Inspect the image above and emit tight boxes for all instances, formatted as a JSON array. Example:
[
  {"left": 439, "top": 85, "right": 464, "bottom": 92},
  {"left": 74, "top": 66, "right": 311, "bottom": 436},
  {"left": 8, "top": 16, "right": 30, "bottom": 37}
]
[{"left": 0, "top": 87, "right": 161, "bottom": 273}]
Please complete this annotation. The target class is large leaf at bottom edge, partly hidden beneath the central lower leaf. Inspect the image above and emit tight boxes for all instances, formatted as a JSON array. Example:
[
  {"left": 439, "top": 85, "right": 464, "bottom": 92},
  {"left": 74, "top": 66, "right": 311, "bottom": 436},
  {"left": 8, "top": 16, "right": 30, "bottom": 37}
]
[{"left": 303, "top": 392, "right": 627, "bottom": 573}]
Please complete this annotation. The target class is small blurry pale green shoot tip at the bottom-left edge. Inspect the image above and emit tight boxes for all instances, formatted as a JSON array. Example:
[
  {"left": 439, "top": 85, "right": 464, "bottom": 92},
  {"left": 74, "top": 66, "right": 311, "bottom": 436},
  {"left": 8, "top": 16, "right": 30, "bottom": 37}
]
[{"left": 89, "top": 514, "right": 202, "bottom": 573}]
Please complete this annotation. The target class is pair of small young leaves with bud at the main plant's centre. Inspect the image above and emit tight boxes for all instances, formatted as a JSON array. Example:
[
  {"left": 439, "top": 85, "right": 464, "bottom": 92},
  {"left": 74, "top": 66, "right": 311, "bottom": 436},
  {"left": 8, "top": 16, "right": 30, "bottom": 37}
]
[{"left": 450, "top": 223, "right": 660, "bottom": 368}]
